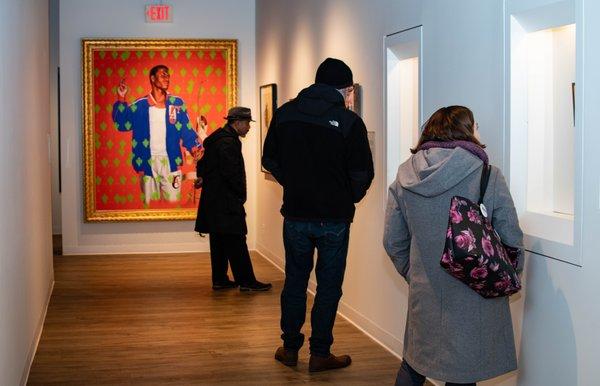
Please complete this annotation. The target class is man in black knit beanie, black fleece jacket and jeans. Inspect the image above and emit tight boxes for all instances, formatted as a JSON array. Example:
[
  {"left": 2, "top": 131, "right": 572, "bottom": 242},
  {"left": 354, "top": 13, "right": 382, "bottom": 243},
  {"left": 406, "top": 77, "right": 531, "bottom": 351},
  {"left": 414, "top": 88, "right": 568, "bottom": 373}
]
[{"left": 262, "top": 58, "right": 373, "bottom": 371}]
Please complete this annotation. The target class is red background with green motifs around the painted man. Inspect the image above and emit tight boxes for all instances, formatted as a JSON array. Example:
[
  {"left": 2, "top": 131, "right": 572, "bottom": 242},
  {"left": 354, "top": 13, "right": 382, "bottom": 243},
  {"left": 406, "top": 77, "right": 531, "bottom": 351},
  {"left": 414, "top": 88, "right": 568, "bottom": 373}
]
[{"left": 93, "top": 50, "right": 228, "bottom": 210}]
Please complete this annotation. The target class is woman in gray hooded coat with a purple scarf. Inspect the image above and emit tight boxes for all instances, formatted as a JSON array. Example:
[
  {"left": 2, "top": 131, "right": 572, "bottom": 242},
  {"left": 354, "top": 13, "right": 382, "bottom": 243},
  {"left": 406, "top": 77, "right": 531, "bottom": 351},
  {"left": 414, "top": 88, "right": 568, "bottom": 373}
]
[{"left": 384, "top": 106, "right": 523, "bottom": 386}]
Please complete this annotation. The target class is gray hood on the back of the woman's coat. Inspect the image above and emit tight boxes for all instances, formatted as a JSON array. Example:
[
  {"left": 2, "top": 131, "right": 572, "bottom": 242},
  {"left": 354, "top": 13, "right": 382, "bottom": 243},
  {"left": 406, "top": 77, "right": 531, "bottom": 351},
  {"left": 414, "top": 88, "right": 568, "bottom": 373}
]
[{"left": 397, "top": 147, "right": 483, "bottom": 197}]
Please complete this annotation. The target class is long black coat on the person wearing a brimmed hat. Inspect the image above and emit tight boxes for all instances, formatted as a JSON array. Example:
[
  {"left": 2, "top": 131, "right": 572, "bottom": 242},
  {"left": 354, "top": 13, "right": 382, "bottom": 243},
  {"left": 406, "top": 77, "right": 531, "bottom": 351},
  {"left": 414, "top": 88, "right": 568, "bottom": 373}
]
[{"left": 195, "top": 125, "right": 248, "bottom": 234}]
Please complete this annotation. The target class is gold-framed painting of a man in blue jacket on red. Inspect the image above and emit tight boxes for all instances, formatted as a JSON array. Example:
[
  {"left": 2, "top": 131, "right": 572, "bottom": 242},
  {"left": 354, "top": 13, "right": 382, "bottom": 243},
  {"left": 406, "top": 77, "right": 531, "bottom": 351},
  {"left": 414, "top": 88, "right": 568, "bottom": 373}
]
[{"left": 82, "top": 39, "right": 237, "bottom": 222}]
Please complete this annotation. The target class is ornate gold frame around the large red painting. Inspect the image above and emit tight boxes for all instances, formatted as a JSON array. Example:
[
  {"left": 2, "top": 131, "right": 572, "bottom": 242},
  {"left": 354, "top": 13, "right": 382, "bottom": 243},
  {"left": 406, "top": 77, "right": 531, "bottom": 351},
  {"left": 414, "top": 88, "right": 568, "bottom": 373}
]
[{"left": 81, "top": 39, "right": 237, "bottom": 222}]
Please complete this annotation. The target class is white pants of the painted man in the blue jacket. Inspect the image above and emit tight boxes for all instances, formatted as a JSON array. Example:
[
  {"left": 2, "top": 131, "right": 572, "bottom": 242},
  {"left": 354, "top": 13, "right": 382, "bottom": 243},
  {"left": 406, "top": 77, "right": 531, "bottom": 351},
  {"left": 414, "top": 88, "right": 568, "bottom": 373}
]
[{"left": 142, "top": 155, "right": 181, "bottom": 205}]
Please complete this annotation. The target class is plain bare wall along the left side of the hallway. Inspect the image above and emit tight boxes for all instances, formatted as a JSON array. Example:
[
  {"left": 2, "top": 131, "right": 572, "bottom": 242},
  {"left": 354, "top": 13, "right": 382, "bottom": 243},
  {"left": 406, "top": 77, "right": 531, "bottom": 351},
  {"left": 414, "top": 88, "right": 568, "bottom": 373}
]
[{"left": 0, "top": 0, "right": 53, "bottom": 385}]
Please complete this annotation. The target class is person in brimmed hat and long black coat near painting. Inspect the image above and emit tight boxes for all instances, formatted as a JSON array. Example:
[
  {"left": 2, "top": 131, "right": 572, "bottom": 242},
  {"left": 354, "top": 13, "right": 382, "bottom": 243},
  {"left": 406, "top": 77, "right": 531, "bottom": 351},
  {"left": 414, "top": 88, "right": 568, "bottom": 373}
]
[{"left": 195, "top": 107, "right": 271, "bottom": 291}]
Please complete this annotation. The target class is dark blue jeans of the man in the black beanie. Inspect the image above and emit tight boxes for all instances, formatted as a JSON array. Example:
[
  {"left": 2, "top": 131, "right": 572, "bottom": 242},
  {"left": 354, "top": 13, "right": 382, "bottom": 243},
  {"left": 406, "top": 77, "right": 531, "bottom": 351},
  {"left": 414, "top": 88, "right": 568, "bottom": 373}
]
[{"left": 281, "top": 219, "right": 350, "bottom": 357}]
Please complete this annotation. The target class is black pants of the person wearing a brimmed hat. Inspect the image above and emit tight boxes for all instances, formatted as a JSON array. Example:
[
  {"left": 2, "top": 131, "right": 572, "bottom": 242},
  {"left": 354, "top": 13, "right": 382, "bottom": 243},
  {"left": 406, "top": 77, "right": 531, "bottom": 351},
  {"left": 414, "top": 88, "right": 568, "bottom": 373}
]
[{"left": 209, "top": 233, "right": 256, "bottom": 284}]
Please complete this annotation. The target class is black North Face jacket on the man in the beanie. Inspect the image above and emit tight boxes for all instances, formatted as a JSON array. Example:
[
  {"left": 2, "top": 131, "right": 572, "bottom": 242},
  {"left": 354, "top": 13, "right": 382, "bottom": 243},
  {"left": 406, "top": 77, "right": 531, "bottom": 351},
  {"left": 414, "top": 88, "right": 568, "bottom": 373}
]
[{"left": 262, "top": 84, "right": 373, "bottom": 222}]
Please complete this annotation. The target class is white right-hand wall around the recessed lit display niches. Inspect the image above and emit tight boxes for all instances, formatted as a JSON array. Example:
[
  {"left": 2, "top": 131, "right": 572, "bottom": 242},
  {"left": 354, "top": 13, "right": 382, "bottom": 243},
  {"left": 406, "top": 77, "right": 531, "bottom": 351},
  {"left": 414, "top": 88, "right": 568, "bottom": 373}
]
[{"left": 254, "top": 0, "right": 600, "bottom": 386}]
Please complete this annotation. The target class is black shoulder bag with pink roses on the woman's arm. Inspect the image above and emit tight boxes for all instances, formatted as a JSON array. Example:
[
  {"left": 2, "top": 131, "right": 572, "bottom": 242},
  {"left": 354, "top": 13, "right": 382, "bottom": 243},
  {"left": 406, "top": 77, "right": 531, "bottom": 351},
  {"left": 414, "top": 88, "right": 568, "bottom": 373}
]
[{"left": 440, "top": 163, "right": 521, "bottom": 298}]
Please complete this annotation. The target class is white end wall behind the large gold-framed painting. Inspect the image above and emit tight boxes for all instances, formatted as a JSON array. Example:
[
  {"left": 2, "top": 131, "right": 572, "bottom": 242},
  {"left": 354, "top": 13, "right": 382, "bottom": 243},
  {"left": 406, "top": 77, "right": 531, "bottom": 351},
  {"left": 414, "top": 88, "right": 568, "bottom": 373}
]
[{"left": 59, "top": 0, "right": 259, "bottom": 254}]
